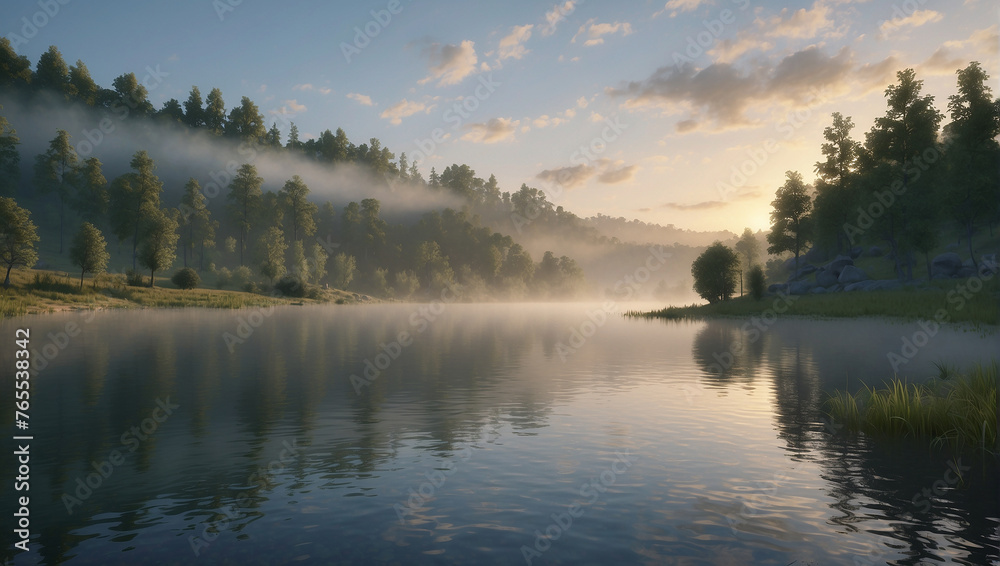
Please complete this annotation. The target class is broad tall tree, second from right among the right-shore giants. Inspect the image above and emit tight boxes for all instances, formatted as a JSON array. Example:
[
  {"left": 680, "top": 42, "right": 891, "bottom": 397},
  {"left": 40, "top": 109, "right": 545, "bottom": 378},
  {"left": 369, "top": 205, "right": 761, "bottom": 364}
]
[{"left": 862, "top": 69, "right": 942, "bottom": 279}]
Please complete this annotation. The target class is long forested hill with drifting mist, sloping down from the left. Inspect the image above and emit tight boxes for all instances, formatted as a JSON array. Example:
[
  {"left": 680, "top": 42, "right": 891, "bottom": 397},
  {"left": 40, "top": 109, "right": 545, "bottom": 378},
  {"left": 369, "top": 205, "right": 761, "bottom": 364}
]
[{"left": 0, "top": 39, "right": 715, "bottom": 300}]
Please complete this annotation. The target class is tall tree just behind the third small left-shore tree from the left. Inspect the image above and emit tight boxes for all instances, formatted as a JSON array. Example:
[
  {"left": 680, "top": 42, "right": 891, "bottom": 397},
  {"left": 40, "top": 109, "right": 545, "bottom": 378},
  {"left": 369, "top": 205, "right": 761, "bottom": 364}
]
[{"left": 108, "top": 151, "right": 163, "bottom": 270}]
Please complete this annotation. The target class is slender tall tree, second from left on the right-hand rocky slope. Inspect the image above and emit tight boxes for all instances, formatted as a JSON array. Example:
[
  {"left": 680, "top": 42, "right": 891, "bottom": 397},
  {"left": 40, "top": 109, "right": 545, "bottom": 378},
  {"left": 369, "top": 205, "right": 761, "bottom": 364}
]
[{"left": 813, "top": 112, "right": 861, "bottom": 252}]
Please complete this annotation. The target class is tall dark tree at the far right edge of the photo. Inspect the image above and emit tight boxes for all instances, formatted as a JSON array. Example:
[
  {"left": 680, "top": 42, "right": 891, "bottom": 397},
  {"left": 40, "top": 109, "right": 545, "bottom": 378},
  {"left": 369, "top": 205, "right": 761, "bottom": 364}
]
[{"left": 946, "top": 61, "right": 1000, "bottom": 269}]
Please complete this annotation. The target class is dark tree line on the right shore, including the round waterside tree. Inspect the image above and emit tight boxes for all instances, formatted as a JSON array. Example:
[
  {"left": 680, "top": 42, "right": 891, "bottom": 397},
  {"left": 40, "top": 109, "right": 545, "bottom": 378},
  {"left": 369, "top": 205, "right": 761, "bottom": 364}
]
[{"left": 692, "top": 62, "right": 1000, "bottom": 302}]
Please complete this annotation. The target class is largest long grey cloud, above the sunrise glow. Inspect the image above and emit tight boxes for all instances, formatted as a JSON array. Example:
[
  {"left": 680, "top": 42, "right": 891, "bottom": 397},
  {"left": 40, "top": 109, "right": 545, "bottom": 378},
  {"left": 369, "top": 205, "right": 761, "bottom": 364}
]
[{"left": 606, "top": 46, "right": 895, "bottom": 132}]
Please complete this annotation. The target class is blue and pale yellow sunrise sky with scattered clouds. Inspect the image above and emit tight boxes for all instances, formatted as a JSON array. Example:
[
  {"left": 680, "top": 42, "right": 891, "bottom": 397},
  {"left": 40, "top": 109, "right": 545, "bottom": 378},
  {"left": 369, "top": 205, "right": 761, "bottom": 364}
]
[{"left": 0, "top": 0, "right": 1000, "bottom": 232}]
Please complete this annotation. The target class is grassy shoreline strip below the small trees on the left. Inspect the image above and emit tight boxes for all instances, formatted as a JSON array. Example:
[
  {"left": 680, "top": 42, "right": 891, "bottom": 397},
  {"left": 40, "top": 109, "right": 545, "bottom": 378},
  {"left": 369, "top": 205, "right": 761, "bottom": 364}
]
[{"left": 0, "top": 269, "right": 355, "bottom": 319}]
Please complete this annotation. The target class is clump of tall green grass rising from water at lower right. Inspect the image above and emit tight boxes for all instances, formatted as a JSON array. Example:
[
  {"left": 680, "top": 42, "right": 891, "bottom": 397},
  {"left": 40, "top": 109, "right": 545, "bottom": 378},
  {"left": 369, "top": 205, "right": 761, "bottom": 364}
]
[{"left": 826, "top": 362, "right": 1000, "bottom": 453}]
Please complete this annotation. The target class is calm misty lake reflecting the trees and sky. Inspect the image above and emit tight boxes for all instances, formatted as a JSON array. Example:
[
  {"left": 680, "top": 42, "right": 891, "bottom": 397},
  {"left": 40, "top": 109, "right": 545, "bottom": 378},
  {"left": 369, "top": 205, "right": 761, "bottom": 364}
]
[{"left": 0, "top": 303, "right": 1000, "bottom": 566}]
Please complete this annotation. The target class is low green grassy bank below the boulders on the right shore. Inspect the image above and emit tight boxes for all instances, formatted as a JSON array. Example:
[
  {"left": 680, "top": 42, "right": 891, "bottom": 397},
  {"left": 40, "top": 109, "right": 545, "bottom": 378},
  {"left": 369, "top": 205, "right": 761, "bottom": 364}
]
[{"left": 626, "top": 278, "right": 1000, "bottom": 325}]
